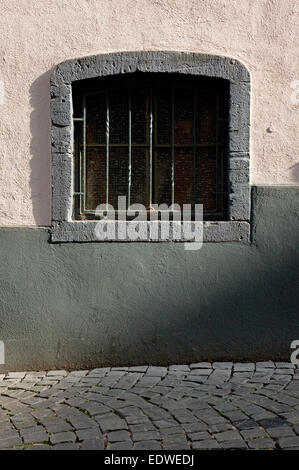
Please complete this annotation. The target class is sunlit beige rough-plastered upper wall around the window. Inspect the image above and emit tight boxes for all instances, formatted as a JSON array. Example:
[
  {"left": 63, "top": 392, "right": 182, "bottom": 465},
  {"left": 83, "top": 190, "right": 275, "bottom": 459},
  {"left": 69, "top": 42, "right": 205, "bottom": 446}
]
[{"left": 0, "top": 0, "right": 299, "bottom": 226}]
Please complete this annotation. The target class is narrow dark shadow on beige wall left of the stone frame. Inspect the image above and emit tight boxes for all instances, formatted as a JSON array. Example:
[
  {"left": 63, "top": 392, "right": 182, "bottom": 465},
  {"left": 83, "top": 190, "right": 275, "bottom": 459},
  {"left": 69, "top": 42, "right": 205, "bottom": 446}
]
[{"left": 30, "top": 70, "right": 51, "bottom": 226}]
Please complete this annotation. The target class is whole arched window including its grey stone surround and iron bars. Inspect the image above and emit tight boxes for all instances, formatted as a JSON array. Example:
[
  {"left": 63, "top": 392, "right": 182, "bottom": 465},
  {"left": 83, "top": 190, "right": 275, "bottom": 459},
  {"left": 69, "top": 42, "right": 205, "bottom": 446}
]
[{"left": 51, "top": 52, "right": 250, "bottom": 242}]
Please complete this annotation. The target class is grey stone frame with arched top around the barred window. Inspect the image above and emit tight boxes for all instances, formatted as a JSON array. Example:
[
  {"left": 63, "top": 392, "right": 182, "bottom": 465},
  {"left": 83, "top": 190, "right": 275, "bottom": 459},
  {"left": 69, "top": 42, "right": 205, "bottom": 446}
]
[{"left": 51, "top": 52, "right": 250, "bottom": 243}]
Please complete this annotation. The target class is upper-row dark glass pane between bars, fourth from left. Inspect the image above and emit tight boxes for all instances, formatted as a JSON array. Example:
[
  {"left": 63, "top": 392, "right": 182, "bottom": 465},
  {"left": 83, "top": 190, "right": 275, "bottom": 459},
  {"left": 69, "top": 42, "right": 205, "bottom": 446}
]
[{"left": 153, "top": 88, "right": 172, "bottom": 145}]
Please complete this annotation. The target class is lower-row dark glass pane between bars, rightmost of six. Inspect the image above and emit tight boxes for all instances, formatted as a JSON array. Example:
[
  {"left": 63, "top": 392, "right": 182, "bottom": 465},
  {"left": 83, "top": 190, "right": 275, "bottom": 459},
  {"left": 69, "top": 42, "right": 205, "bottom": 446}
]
[{"left": 197, "top": 147, "right": 217, "bottom": 211}]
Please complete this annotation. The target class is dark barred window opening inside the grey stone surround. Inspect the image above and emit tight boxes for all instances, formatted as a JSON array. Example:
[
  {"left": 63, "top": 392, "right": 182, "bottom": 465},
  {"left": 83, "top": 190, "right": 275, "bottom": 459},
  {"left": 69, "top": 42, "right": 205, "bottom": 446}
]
[{"left": 73, "top": 73, "right": 229, "bottom": 220}]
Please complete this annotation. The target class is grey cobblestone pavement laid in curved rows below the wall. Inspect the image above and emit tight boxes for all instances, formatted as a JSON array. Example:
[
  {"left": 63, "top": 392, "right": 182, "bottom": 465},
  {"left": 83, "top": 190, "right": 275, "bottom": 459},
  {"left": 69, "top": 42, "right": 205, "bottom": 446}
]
[{"left": 0, "top": 362, "right": 299, "bottom": 450}]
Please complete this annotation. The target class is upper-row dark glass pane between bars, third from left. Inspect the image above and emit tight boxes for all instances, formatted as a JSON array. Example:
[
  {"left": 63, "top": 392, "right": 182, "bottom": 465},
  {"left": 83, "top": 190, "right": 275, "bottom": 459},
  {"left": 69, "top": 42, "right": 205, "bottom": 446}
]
[{"left": 131, "top": 88, "right": 149, "bottom": 144}]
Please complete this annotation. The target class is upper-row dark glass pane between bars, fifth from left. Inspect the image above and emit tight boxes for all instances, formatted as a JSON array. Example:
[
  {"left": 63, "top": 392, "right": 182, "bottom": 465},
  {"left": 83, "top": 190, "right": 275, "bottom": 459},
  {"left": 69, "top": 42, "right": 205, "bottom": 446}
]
[{"left": 174, "top": 89, "right": 194, "bottom": 145}]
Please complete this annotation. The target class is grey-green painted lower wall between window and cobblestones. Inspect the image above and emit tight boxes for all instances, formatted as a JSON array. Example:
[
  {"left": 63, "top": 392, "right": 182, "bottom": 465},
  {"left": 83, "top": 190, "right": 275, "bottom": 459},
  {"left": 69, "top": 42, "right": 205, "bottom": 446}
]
[{"left": 0, "top": 187, "right": 299, "bottom": 370}]
